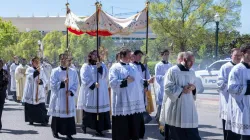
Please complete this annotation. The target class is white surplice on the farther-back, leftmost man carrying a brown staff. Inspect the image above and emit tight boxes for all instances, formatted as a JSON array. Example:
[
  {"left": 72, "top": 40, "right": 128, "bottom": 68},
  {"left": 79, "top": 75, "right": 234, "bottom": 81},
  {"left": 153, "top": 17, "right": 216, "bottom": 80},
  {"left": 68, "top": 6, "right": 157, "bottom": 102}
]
[{"left": 22, "top": 67, "right": 48, "bottom": 105}]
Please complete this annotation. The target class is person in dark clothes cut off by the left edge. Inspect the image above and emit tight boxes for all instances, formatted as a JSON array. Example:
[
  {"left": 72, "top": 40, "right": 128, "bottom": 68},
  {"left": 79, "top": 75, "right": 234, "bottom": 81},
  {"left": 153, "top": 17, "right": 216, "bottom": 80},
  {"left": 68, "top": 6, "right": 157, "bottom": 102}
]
[{"left": 0, "top": 59, "right": 9, "bottom": 130}]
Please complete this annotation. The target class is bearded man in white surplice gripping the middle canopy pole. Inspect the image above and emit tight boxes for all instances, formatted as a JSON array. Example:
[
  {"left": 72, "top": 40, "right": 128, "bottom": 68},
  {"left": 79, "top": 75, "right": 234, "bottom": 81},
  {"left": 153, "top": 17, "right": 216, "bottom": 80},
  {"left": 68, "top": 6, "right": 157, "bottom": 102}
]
[{"left": 77, "top": 50, "right": 111, "bottom": 136}]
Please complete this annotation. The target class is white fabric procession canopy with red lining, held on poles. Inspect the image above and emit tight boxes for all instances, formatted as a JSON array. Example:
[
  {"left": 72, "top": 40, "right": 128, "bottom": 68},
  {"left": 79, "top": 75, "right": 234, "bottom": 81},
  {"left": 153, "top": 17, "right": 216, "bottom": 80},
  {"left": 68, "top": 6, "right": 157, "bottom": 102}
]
[{"left": 65, "top": 3, "right": 147, "bottom": 36}]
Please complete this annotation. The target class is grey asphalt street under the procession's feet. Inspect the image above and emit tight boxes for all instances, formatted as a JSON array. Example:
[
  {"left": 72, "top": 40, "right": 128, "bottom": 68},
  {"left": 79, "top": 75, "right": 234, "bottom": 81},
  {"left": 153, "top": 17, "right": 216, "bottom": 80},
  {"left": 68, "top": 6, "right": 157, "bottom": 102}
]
[{"left": 0, "top": 94, "right": 223, "bottom": 140}]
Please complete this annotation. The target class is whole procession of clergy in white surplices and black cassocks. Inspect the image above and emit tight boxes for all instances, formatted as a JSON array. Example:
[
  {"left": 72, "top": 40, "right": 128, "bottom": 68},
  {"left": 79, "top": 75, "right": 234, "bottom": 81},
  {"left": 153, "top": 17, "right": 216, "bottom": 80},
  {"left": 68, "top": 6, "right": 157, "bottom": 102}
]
[{"left": 0, "top": 44, "right": 250, "bottom": 140}]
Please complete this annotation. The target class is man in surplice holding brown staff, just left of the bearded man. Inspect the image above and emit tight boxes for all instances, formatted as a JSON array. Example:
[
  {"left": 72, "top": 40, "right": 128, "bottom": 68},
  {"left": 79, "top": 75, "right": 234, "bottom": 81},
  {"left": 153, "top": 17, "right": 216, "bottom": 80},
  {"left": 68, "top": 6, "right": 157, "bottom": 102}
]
[{"left": 48, "top": 54, "right": 78, "bottom": 140}]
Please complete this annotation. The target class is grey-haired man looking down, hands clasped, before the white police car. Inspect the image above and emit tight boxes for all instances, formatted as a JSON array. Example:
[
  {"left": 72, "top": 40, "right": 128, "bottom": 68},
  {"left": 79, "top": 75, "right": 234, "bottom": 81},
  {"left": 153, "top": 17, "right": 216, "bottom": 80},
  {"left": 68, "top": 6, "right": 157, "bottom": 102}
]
[{"left": 164, "top": 52, "right": 203, "bottom": 140}]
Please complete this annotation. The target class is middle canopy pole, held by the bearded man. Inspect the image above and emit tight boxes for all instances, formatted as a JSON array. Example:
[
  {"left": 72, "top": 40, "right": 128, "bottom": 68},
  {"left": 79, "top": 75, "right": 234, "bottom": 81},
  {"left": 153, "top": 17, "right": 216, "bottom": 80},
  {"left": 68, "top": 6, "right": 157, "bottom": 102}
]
[{"left": 95, "top": 1, "right": 100, "bottom": 121}]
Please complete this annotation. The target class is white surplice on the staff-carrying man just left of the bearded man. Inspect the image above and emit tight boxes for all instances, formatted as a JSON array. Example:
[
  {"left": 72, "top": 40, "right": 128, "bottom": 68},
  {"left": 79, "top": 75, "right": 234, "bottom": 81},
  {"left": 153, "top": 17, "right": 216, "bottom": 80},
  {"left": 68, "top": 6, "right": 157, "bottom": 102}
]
[{"left": 48, "top": 67, "right": 78, "bottom": 118}]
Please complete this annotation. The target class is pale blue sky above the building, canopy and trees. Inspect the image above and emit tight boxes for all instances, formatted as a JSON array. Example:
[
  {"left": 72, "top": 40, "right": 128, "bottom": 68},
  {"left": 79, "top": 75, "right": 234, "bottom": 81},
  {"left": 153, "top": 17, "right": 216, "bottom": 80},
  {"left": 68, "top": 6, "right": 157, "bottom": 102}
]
[{"left": 0, "top": 0, "right": 250, "bottom": 34}]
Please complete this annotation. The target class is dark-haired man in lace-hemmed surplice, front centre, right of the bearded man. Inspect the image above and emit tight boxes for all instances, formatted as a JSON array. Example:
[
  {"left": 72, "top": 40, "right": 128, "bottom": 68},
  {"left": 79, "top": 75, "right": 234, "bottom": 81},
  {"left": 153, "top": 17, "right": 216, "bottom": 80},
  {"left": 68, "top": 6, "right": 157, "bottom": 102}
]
[{"left": 109, "top": 48, "right": 153, "bottom": 140}]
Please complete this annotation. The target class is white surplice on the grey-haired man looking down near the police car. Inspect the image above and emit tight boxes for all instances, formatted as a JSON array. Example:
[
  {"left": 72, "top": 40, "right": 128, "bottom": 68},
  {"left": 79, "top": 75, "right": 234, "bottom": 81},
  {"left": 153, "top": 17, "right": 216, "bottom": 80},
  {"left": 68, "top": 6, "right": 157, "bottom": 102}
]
[{"left": 161, "top": 65, "right": 204, "bottom": 128}]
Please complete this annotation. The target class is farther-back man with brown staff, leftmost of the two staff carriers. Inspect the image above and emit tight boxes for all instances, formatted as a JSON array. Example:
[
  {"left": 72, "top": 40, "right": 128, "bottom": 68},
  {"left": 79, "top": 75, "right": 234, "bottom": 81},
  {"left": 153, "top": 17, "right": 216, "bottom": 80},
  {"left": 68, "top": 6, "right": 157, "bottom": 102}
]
[{"left": 22, "top": 57, "right": 49, "bottom": 126}]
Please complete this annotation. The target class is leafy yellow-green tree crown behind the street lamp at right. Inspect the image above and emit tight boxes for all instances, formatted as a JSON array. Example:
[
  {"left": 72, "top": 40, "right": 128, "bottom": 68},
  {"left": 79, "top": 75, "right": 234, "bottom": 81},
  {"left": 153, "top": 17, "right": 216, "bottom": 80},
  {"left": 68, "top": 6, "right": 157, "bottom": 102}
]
[{"left": 150, "top": 0, "right": 241, "bottom": 52}]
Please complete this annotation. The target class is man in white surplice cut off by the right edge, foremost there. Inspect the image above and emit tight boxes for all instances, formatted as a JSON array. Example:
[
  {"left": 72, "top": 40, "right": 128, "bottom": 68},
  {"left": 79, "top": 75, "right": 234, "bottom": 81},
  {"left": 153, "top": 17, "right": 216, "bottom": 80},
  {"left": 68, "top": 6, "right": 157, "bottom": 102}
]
[{"left": 226, "top": 43, "right": 250, "bottom": 140}]
